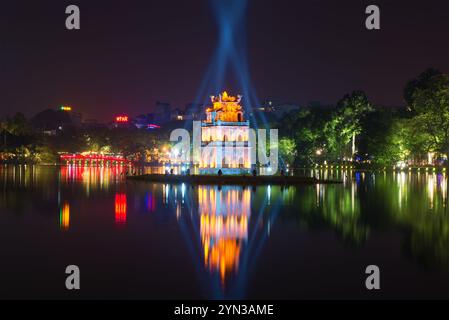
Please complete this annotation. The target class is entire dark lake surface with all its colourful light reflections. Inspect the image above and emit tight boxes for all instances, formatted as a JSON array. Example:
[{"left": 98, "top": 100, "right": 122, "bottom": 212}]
[{"left": 0, "top": 166, "right": 449, "bottom": 299}]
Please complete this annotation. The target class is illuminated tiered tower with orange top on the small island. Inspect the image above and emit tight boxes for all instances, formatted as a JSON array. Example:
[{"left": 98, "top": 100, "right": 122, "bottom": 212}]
[{"left": 200, "top": 91, "right": 251, "bottom": 174}]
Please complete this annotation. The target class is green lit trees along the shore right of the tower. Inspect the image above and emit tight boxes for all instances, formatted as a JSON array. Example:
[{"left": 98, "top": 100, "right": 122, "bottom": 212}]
[{"left": 278, "top": 69, "right": 449, "bottom": 166}]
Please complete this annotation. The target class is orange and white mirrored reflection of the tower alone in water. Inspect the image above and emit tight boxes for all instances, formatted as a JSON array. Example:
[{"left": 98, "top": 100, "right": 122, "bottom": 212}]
[{"left": 198, "top": 186, "right": 251, "bottom": 283}]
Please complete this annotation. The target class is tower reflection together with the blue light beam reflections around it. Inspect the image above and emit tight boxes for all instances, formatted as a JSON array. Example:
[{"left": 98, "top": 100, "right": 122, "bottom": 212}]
[{"left": 161, "top": 184, "right": 268, "bottom": 298}]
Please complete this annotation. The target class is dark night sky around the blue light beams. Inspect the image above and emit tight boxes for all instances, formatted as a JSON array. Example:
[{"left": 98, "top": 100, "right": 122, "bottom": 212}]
[{"left": 0, "top": 0, "right": 449, "bottom": 121}]
